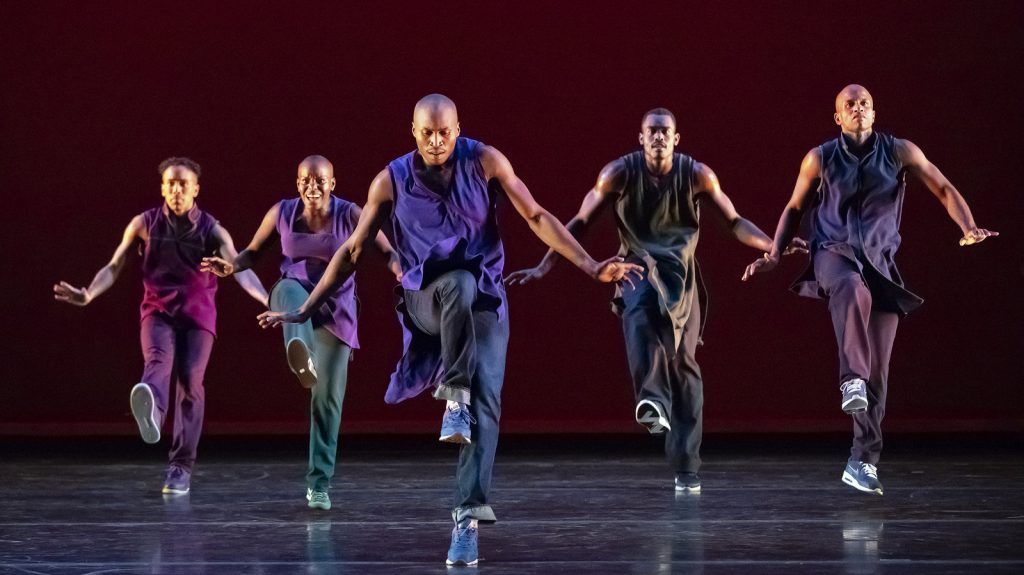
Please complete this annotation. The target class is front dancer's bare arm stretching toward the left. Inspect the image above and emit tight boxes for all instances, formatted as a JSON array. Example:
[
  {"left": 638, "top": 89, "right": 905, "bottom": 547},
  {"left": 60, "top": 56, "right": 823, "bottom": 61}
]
[{"left": 258, "top": 169, "right": 394, "bottom": 327}]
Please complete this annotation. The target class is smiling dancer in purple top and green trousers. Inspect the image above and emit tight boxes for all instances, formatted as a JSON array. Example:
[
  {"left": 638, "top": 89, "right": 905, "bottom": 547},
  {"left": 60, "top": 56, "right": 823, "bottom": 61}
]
[{"left": 202, "top": 156, "right": 400, "bottom": 511}]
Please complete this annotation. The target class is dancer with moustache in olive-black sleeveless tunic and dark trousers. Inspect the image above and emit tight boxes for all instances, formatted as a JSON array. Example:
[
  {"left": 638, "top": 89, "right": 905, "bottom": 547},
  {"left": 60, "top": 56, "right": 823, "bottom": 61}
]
[{"left": 505, "top": 107, "right": 802, "bottom": 493}]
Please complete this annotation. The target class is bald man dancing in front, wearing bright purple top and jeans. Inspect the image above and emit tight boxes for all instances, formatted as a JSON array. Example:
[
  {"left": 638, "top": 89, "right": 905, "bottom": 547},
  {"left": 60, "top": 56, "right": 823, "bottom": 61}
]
[{"left": 259, "top": 94, "right": 640, "bottom": 565}]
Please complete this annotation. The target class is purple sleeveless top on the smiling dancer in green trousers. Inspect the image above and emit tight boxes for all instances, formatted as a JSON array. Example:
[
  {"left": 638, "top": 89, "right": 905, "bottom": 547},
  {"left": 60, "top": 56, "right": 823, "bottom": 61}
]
[{"left": 278, "top": 195, "right": 359, "bottom": 349}]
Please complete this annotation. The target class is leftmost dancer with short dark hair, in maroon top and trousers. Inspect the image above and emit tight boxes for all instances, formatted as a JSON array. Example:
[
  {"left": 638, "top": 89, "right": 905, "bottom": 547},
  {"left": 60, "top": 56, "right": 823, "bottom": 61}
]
[{"left": 53, "top": 158, "right": 266, "bottom": 495}]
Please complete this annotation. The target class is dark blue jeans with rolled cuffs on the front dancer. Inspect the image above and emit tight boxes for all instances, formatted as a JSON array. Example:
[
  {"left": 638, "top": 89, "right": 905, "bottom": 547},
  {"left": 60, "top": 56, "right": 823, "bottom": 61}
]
[{"left": 406, "top": 270, "right": 509, "bottom": 522}]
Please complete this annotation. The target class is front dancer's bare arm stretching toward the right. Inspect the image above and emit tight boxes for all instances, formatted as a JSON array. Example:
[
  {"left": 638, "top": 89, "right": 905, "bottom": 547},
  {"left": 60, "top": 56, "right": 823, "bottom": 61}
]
[{"left": 480, "top": 146, "right": 643, "bottom": 282}]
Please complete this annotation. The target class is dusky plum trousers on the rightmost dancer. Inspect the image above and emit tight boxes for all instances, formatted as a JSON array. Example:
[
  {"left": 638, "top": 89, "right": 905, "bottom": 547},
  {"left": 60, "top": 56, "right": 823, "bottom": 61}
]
[{"left": 814, "top": 250, "right": 899, "bottom": 465}]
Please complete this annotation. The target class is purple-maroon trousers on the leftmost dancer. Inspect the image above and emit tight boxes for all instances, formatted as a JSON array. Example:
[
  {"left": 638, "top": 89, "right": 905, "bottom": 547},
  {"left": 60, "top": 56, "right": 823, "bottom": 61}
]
[{"left": 139, "top": 314, "right": 215, "bottom": 471}]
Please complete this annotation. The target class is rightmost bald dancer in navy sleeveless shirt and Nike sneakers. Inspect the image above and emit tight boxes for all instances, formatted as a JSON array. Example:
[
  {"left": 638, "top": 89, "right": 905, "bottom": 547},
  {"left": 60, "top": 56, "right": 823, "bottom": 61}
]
[{"left": 743, "top": 84, "right": 998, "bottom": 495}]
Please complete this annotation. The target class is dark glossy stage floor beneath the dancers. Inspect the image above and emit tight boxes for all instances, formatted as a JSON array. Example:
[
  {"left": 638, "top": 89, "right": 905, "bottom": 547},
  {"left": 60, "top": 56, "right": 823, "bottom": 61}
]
[{"left": 0, "top": 435, "right": 1024, "bottom": 575}]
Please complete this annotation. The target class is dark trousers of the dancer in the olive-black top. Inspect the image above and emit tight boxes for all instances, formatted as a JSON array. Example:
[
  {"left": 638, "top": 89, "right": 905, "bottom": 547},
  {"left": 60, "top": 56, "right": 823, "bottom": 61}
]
[{"left": 623, "top": 279, "right": 703, "bottom": 473}]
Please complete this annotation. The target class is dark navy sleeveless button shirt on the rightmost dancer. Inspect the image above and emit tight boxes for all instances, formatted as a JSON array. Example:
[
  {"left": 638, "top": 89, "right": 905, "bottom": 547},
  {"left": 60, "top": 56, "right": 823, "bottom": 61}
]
[{"left": 792, "top": 132, "right": 924, "bottom": 314}]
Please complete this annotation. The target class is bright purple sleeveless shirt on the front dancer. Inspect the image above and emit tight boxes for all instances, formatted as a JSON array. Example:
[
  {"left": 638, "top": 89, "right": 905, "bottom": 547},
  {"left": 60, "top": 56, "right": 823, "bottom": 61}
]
[{"left": 384, "top": 138, "right": 508, "bottom": 403}]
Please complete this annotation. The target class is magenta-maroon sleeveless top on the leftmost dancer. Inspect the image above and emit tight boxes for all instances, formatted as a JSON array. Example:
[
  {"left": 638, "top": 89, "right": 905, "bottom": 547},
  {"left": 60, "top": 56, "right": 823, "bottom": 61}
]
[{"left": 139, "top": 206, "right": 218, "bottom": 335}]
